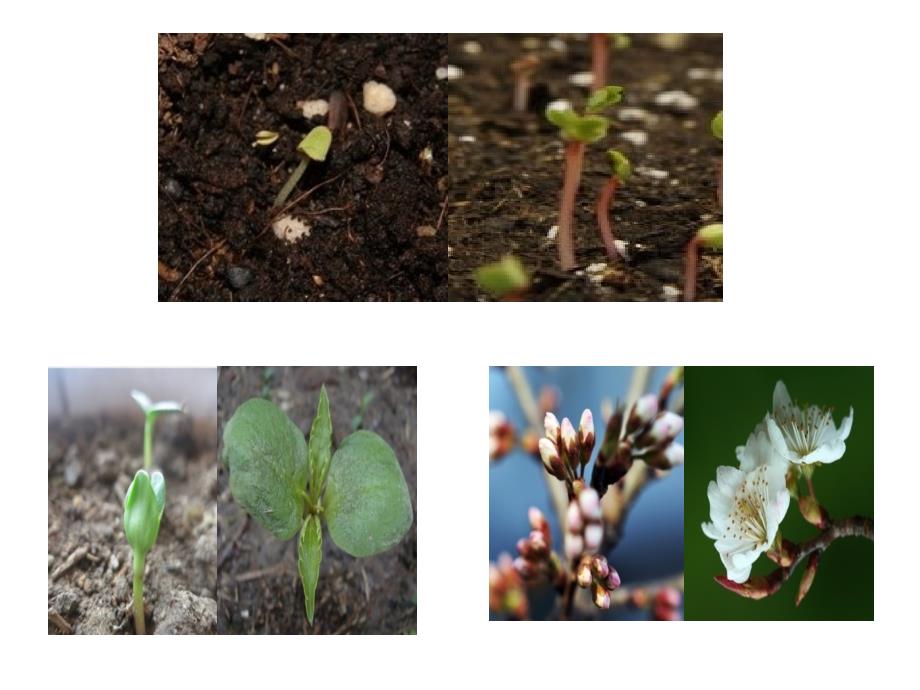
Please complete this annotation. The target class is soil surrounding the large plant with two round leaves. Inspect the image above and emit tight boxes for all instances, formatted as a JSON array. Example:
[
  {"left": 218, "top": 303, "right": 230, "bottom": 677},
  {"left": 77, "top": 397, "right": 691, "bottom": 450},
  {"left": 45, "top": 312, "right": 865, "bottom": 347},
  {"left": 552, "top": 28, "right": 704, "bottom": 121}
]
[{"left": 217, "top": 367, "right": 418, "bottom": 634}]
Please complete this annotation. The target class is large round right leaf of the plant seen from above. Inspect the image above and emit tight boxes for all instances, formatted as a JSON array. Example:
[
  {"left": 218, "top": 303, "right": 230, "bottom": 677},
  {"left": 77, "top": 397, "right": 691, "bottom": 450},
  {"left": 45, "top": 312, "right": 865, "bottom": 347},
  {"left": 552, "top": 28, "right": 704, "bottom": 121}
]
[{"left": 324, "top": 431, "right": 412, "bottom": 557}]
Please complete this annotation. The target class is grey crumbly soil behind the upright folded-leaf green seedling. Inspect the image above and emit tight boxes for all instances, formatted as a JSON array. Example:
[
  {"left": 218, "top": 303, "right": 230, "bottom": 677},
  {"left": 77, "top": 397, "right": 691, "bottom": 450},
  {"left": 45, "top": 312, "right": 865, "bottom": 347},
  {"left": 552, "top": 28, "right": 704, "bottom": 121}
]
[{"left": 48, "top": 415, "right": 217, "bottom": 634}]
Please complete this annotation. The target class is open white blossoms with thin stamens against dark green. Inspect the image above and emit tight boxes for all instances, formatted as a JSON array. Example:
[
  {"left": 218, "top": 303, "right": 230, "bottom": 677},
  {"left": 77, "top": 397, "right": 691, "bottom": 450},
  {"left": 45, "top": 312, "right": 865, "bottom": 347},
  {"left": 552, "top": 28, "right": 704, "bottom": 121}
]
[{"left": 703, "top": 381, "right": 853, "bottom": 583}]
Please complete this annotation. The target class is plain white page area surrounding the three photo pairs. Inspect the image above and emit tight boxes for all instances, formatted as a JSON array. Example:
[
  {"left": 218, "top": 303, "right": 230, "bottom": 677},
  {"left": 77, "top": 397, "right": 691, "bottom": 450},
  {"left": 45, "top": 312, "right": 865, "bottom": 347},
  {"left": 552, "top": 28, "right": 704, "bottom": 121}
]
[{"left": 0, "top": 0, "right": 920, "bottom": 689}]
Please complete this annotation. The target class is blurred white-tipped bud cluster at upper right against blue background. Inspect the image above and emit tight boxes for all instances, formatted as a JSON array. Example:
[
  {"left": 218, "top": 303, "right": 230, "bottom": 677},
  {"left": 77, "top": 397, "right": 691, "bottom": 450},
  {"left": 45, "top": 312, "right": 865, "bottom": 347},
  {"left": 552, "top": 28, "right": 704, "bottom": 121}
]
[{"left": 591, "top": 393, "right": 684, "bottom": 495}]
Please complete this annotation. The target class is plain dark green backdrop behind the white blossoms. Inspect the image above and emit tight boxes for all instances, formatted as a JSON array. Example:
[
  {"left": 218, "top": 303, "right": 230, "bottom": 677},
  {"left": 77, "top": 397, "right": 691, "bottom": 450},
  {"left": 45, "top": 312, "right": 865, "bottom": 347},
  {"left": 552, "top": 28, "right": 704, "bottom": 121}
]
[{"left": 684, "top": 367, "right": 874, "bottom": 620}]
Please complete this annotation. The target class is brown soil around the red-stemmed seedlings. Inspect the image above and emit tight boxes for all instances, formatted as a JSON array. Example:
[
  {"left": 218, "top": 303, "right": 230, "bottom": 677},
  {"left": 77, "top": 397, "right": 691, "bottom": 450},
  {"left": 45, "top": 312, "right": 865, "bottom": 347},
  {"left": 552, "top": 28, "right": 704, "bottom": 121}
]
[{"left": 448, "top": 34, "right": 722, "bottom": 301}]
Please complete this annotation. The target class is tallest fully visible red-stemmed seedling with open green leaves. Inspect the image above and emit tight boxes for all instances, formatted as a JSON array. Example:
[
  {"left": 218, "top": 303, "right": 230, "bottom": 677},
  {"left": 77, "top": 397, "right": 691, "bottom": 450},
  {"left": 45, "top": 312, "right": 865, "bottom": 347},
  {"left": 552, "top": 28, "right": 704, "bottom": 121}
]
[{"left": 546, "top": 86, "right": 623, "bottom": 271}]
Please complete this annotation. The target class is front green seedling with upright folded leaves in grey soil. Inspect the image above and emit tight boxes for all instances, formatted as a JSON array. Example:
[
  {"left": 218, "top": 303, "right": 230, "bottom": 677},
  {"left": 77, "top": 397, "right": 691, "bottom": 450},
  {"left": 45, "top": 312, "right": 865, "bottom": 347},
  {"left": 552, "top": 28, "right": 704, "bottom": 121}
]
[{"left": 125, "top": 470, "right": 166, "bottom": 635}]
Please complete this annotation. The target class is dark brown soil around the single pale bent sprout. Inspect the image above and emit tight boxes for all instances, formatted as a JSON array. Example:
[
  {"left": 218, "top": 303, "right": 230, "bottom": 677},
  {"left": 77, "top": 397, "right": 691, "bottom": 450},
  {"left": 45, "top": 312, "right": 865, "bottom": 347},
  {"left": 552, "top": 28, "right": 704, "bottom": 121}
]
[{"left": 158, "top": 34, "right": 447, "bottom": 301}]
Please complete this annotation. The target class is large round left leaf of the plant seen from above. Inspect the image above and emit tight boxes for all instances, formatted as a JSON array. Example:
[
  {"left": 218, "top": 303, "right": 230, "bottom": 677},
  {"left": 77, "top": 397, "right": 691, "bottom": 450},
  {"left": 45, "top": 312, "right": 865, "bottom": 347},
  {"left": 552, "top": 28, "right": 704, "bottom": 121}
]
[{"left": 224, "top": 398, "right": 309, "bottom": 539}]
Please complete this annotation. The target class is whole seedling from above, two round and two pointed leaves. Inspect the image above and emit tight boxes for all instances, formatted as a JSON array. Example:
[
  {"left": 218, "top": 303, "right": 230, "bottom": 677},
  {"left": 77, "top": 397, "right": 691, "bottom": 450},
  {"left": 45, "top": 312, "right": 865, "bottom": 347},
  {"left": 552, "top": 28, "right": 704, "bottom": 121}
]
[{"left": 223, "top": 386, "right": 412, "bottom": 625}]
